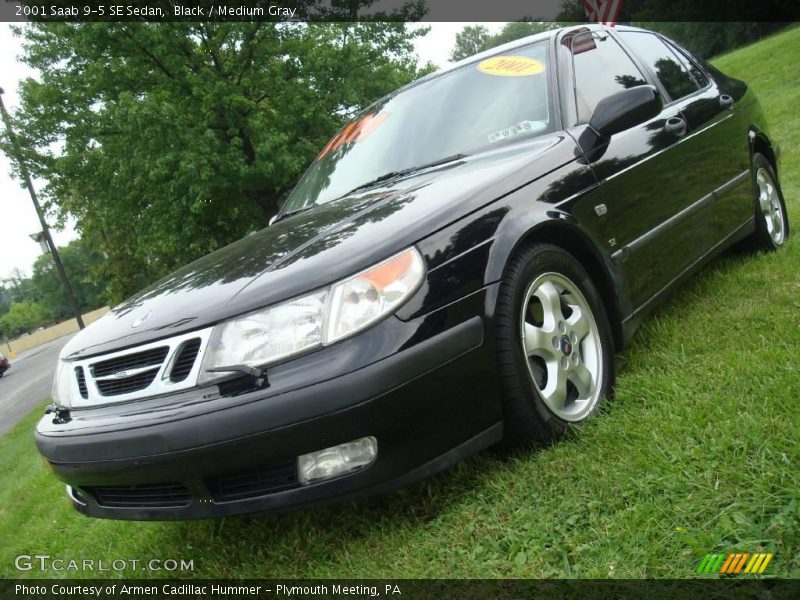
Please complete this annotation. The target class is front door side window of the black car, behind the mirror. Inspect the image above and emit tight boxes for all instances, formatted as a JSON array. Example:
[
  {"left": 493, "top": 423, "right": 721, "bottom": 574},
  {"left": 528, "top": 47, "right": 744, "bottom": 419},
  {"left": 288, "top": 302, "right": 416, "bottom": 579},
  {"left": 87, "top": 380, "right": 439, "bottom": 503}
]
[{"left": 562, "top": 33, "right": 647, "bottom": 123}]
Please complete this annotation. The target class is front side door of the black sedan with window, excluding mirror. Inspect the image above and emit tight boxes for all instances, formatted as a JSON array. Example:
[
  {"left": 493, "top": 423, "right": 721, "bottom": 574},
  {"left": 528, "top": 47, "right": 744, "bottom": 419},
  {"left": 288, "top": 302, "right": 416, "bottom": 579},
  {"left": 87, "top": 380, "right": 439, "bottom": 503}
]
[{"left": 559, "top": 28, "right": 704, "bottom": 314}]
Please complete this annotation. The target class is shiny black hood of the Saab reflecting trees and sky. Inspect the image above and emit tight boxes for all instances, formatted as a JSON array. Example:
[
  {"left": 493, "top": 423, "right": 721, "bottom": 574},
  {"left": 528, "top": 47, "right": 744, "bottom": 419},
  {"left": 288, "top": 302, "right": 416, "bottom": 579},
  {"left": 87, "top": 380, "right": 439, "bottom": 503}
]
[{"left": 61, "top": 134, "right": 575, "bottom": 359}]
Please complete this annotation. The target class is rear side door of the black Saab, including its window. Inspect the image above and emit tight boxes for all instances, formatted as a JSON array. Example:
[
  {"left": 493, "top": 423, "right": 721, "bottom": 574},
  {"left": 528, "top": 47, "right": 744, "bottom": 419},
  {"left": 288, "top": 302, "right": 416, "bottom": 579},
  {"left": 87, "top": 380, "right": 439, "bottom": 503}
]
[{"left": 618, "top": 29, "right": 752, "bottom": 249}]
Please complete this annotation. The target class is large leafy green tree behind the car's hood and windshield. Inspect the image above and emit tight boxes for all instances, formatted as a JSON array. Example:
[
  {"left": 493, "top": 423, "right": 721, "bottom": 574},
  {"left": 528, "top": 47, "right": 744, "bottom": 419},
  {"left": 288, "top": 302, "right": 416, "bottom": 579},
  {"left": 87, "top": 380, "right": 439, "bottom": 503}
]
[{"left": 6, "top": 15, "right": 432, "bottom": 302}]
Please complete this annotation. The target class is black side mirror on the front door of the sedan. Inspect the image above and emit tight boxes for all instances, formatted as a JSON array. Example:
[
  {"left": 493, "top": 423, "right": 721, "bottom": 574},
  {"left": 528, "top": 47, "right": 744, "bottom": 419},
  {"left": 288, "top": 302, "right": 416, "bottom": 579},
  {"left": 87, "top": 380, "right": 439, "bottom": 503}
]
[{"left": 589, "top": 85, "right": 664, "bottom": 138}]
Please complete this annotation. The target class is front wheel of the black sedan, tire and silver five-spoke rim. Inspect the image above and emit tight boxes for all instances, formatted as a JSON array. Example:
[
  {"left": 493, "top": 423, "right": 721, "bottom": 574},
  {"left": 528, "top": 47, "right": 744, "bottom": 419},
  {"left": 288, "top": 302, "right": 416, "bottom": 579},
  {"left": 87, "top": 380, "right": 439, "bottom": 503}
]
[{"left": 496, "top": 244, "right": 614, "bottom": 445}]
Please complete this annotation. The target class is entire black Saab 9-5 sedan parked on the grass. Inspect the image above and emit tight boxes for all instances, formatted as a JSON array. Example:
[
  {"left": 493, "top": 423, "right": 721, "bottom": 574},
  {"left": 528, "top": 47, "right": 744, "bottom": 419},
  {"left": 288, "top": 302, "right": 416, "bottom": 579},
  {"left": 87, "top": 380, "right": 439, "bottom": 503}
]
[{"left": 36, "top": 25, "right": 789, "bottom": 519}]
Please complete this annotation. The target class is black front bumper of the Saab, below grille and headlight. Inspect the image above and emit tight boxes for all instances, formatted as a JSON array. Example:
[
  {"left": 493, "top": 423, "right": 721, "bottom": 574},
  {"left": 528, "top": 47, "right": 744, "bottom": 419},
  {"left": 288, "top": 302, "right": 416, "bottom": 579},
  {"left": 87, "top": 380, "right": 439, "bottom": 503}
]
[{"left": 36, "top": 293, "right": 502, "bottom": 519}]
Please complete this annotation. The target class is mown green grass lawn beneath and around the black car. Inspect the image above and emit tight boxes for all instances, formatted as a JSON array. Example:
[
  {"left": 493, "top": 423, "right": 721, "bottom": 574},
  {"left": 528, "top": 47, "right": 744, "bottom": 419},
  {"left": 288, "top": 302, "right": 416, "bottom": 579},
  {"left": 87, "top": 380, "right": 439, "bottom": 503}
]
[{"left": 0, "top": 28, "right": 800, "bottom": 578}]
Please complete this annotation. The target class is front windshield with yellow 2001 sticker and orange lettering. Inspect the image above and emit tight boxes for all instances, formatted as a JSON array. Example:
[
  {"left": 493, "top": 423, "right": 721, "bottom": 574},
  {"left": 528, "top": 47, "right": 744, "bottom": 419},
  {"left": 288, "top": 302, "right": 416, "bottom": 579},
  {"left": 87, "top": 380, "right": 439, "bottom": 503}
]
[{"left": 281, "top": 42, "right": 553, "bottom": 215}]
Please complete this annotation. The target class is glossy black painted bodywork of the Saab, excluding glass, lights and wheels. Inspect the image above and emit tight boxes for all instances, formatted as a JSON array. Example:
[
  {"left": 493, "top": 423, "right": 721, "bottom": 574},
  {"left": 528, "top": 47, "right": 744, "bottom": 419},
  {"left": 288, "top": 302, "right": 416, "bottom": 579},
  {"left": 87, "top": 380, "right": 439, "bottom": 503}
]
[{"left": 36, "top": 26, "right": 777, "bottom": 519}]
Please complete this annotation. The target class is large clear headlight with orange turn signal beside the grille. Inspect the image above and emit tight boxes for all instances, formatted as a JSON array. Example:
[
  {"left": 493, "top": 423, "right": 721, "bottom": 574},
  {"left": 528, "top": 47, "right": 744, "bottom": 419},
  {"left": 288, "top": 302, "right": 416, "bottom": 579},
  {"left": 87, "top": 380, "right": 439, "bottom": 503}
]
[{"left": 198, "top": 248, "right": 425, "bottom": 384}]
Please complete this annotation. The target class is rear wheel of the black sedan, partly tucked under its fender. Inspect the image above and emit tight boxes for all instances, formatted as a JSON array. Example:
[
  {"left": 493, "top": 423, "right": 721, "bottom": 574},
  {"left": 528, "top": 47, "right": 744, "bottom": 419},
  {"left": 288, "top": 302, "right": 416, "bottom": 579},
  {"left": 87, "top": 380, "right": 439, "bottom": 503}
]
[{"left": 752, "top": 153, "right": 789, "bottom": 251}]
